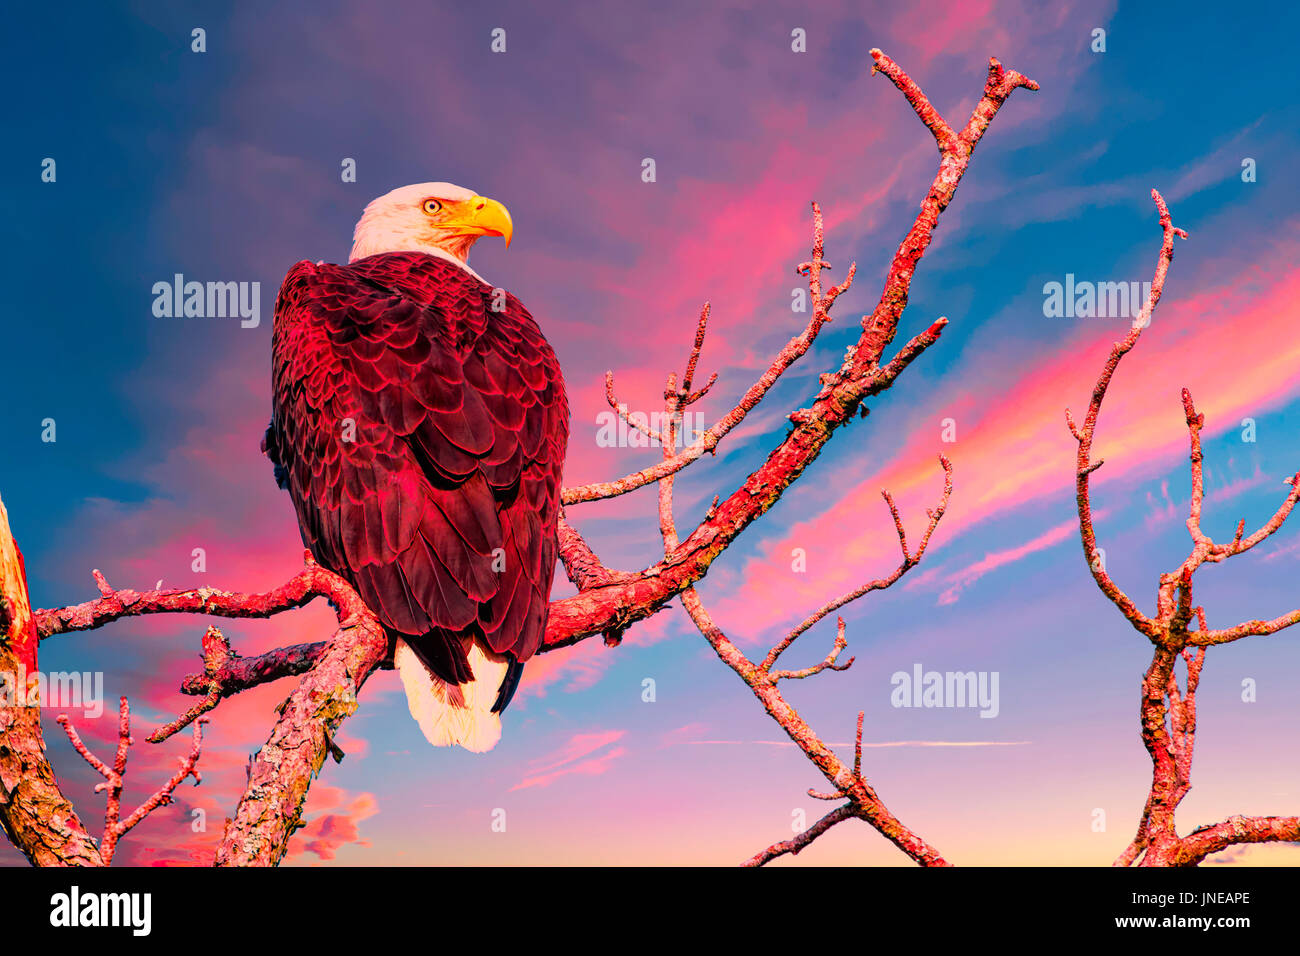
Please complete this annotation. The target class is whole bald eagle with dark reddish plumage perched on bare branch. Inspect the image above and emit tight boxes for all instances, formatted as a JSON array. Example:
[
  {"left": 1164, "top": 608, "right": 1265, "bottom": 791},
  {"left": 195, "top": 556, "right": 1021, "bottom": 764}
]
[{"left": 264, "top": 182, "right": 568, "bottom": 752}]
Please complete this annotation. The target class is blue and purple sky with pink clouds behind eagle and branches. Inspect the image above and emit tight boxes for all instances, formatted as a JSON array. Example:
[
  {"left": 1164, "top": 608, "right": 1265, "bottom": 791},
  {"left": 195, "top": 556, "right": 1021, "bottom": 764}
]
[{"left": 0, "top": 0, "right": 1300, "bottom": 865}]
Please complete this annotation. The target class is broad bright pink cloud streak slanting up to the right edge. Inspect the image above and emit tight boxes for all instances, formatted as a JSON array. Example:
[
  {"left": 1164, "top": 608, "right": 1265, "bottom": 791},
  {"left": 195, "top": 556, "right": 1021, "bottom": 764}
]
[{"left": 715, "top": 222, "right": 1300, "bottom": 636}]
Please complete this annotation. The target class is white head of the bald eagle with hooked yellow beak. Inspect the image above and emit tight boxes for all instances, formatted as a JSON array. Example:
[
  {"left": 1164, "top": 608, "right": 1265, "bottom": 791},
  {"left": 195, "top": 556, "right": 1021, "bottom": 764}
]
[{"left": 348, "top": 182, "right": 514, "bottom": 265}]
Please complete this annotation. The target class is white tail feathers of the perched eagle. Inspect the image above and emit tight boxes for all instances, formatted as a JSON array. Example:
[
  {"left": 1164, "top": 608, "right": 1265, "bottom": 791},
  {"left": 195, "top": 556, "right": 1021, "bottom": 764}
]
[{"left": 393, "top": 639, "right": 510, "bottom": 753}]
